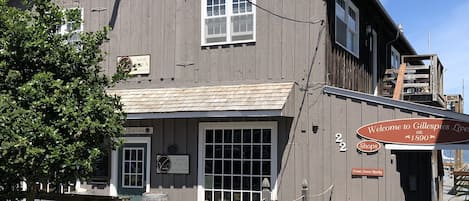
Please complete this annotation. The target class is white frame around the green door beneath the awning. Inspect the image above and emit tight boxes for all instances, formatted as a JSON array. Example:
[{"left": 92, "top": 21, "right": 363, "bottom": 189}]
[{"left": 109, "top": 137, "right": 151, "bottom": 196}]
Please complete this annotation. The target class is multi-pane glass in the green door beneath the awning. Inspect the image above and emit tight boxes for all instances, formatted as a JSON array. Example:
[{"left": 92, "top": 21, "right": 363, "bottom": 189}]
[{"left": 122, "top": 147, "right": 145, "bottom": 188}]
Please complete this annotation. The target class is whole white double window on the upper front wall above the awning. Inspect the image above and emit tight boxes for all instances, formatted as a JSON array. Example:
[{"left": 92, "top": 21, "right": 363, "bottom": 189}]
[{"left": 201, "top": 0, "right": 256, "bottom": 45}]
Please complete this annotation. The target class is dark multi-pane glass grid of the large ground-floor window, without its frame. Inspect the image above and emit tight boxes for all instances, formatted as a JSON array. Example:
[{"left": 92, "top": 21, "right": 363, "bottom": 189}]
[{"left": 204, "top": 129, "right": 272, "bottom": 201}]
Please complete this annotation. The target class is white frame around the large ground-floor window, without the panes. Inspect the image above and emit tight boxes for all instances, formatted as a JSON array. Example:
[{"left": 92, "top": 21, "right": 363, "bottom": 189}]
[{"left": 197, "top": 121, "right": 278, "bottom": 201}]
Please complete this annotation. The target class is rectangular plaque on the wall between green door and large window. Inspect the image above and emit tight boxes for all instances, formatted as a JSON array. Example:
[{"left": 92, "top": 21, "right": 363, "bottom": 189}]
[{"left": 156, "top": 155, "right": 189, "bottom": 174}]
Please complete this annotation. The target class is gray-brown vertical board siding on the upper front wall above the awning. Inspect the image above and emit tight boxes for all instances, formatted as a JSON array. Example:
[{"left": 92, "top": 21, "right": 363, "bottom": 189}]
[{"left": 64, "top": 0, "right": 326, "bottom": 88}]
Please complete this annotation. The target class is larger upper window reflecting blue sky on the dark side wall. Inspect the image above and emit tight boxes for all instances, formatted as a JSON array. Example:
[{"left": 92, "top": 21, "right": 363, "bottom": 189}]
[{"left": 335, "top": 0, "right": 360, "bottom": 57}]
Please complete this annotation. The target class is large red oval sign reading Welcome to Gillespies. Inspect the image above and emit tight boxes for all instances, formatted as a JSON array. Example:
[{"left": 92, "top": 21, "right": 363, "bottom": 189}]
[{"left": 357, "top": 118, "right": 469, "bottom": 145}]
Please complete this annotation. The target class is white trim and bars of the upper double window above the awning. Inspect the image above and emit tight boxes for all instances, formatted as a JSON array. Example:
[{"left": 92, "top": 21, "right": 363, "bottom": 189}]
[{"left": 200, "top": 0, "right": 256, "bottom": 46}]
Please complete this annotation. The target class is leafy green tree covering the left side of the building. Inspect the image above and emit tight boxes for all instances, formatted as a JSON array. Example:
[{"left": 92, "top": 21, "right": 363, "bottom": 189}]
[{"left": 0, "top": 0, "right": 128, "bottom": 200}]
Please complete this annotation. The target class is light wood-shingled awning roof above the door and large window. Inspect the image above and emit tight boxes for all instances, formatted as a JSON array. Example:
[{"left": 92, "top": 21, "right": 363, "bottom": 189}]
[{"left": 109, "top": 82, "right": 293, "bottom": 119}]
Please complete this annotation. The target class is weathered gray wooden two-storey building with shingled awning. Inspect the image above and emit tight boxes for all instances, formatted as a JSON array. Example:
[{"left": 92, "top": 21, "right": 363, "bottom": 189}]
[{"left": 18, "top": 0, "right": 469, "bottom": 201}]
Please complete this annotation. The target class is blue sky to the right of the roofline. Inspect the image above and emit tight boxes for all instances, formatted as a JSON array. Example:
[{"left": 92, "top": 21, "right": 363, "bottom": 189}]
[{"left": 381, "top": 0, "right": 469, "bottom": 114}]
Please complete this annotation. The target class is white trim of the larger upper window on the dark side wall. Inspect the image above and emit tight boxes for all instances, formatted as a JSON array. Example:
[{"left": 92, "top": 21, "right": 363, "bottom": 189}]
[{"left": 334, "top": 0, "right": 360, "bottom": 58}]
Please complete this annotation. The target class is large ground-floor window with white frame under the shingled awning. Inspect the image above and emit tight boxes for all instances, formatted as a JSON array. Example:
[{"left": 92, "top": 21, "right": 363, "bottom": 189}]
[{"left": 198, "top": 122, "right": 277, "bottom": 201}]
